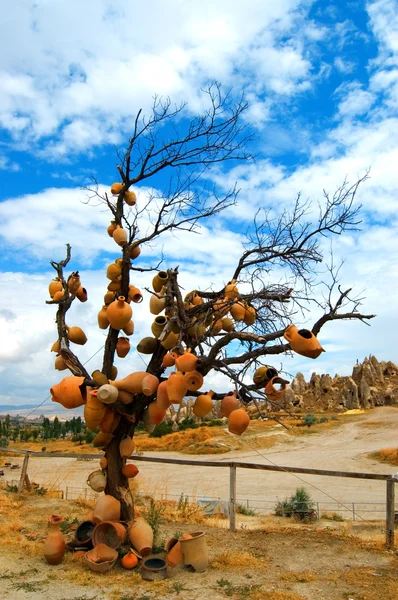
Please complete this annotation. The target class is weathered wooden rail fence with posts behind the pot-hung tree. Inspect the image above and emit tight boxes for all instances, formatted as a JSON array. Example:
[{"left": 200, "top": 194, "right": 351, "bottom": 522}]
[{"left": 0, "top": 448, "right": 398, "bottom": 549}]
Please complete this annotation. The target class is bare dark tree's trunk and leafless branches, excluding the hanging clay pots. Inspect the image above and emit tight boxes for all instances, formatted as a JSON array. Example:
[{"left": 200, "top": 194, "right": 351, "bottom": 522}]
[{"left": 48, "top": 85, "right": 374, "bottom": 521}]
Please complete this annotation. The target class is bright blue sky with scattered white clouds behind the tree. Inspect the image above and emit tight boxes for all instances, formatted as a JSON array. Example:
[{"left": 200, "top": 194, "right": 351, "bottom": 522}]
[{"left": 0, "top": 0, "right": 398, "bottom": 404}]
